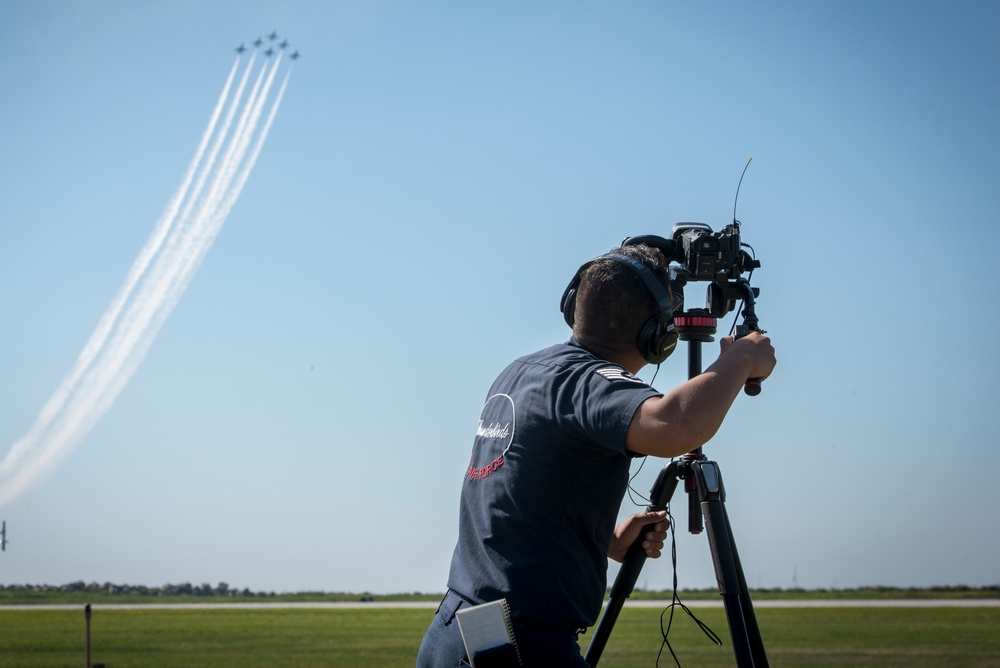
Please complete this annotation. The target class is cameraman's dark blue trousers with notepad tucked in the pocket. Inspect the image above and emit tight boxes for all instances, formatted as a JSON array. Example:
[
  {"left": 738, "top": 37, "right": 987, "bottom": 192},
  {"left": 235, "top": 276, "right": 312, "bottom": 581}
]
[{"left": 417, "top": 591, "right": 588, "bottom": 668}]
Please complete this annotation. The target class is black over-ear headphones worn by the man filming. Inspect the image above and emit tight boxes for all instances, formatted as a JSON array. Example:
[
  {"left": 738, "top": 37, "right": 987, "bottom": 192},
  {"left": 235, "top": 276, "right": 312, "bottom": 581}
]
[{"left": 559, "top": 235, "right": 677, "bottom": 364}]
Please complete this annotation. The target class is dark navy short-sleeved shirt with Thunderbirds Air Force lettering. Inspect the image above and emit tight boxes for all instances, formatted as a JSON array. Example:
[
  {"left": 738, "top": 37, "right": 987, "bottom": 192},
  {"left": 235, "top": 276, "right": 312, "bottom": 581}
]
[{"left": 448, "top": 339, "right": 660, "bottom": 629}]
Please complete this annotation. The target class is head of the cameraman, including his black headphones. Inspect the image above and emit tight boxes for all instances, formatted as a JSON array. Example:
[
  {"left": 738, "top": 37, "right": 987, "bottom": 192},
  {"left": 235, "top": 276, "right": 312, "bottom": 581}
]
[{"left": 562, "top": 244, "right": 677, "bottom": 364}]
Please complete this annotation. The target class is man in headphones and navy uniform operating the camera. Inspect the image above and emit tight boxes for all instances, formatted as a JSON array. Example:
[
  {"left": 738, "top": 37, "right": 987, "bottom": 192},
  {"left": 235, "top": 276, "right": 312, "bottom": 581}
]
[{"left": 417, "top": 238, "right": 775, "bottom": 668}]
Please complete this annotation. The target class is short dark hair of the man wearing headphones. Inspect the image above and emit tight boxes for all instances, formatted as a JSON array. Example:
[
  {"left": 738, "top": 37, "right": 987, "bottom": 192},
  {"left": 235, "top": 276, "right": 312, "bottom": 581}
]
[{"left": 573, "top": 244, "right": 670, "bottom": 353}]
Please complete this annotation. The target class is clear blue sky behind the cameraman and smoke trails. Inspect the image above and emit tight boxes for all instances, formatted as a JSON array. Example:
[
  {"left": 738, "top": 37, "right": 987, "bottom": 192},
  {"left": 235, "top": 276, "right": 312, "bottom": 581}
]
[{"left": 0, "top": 0, "right": 1000, "bottom": 592}]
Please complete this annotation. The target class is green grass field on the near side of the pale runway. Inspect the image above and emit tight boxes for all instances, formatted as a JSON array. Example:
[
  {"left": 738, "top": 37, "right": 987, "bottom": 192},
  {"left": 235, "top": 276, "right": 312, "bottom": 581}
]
[{"left": 0, "top": 607, "right": 1000, "bottom": 668}]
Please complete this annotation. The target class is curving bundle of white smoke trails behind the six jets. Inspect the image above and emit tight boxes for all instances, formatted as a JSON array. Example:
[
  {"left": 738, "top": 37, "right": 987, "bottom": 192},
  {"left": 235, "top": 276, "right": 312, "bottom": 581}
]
[{"left": 0, "top": 45, "right": 291, "bottom": 507}]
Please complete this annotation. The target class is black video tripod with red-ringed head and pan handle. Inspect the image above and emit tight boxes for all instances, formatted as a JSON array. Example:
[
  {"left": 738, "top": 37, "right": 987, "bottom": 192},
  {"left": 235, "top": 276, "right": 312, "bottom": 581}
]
[{"left": 586, "top": 288, "right": 769, "bottom": 668}]
